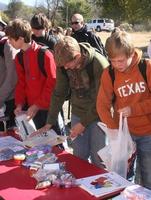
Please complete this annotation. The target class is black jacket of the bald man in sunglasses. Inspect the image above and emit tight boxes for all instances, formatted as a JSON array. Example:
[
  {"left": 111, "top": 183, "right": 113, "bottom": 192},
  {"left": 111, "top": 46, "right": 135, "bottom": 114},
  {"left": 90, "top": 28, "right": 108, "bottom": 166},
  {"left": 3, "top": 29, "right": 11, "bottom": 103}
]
[{"left": 72, "top": 26, "right": 107, "bottom": 57}]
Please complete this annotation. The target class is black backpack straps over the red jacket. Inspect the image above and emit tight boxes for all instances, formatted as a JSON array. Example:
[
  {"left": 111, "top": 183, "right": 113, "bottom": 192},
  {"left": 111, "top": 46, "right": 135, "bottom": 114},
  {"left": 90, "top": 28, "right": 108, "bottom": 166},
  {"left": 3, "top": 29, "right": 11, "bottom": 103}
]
[{"left": 17, "top": 46, "right": 49, "bottom": 77}]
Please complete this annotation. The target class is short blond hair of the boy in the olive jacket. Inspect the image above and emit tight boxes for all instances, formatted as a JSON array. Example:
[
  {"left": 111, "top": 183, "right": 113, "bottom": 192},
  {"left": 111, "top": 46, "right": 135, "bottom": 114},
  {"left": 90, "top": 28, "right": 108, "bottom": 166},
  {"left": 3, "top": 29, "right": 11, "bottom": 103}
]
[{"left": 54, "top": 36, "right": 80, "bottom": 66}]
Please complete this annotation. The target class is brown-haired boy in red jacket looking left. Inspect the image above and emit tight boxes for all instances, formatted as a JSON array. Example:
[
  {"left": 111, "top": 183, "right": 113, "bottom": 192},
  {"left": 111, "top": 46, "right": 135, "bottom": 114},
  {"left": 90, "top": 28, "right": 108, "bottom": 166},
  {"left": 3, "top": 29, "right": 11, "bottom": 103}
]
[{"left": 6, "top": 19, "right": 56, "bottom": 128}]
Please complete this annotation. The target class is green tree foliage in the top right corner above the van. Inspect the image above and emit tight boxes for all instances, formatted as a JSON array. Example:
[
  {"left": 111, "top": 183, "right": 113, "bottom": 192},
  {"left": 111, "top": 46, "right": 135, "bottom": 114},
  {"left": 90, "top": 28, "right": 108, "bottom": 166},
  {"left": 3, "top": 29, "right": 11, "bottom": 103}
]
[{"left": 95, "top": 0, "right": 151, "bottom": 24}]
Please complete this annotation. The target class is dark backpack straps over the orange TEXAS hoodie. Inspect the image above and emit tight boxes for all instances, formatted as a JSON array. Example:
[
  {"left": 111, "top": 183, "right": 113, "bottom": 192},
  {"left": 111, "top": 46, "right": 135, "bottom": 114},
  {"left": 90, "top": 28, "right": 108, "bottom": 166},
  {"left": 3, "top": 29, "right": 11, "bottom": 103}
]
[{"left": 109, "top": 59, "right": 147, "bottom": 104}]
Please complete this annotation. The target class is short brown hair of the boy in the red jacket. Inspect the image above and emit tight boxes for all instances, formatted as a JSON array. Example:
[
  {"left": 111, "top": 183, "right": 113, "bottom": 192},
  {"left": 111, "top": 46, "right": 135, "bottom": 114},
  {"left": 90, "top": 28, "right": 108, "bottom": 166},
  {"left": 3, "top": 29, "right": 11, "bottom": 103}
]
[{"left": 5, "top": 19, "right": 32, "bottom": 43}]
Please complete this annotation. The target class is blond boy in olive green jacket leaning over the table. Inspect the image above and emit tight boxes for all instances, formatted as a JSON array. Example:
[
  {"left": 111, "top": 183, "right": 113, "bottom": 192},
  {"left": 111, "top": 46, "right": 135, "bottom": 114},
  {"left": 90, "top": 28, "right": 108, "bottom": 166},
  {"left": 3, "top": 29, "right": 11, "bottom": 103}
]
[{"left": 33, "top": 36, "right": 109, "bottom": 167}]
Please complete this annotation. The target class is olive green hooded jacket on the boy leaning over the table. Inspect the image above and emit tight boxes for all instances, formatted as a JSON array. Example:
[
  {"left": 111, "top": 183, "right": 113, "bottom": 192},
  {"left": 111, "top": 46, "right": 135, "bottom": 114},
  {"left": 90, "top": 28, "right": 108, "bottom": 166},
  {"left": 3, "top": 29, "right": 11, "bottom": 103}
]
[{"left": 47, "top": 43, "right": 109, "bottom": 127}]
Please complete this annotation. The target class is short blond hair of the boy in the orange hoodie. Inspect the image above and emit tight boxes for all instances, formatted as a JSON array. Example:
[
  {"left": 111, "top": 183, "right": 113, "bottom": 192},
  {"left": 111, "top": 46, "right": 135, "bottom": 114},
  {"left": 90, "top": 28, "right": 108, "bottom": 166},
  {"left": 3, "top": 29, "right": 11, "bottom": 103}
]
[{"left": 105, "top": 29, "right": 134, "bottom": 58}]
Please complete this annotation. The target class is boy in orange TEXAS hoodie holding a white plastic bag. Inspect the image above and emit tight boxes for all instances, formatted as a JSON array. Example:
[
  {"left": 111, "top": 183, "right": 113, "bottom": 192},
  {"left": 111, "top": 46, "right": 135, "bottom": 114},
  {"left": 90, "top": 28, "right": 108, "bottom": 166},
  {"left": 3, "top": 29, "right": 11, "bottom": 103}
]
[{"left": 97, "top": 30, "right": 151, "bottom": 189}]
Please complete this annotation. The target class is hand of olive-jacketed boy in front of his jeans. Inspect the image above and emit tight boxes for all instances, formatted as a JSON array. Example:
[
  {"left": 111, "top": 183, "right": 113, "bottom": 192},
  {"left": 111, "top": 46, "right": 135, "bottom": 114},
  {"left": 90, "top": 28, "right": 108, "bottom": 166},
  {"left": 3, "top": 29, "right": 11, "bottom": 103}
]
[{"left": 69, "top": 123, "right": 85, "bottom": 139}]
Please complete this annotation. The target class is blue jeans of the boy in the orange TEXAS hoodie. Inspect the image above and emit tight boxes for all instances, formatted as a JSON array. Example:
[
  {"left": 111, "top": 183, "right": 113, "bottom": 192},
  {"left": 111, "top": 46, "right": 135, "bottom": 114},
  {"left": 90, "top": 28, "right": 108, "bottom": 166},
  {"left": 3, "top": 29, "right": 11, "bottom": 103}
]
[{"left": 132, "top": 135, "right": 151, "bottom": 189}]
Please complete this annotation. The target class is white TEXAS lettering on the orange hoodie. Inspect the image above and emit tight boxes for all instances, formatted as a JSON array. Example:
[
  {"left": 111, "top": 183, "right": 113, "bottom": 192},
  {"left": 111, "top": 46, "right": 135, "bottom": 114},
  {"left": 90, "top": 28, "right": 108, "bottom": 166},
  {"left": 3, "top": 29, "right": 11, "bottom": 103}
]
[{"left": 117, "top": 82, "right": 146, "bottom": 97}]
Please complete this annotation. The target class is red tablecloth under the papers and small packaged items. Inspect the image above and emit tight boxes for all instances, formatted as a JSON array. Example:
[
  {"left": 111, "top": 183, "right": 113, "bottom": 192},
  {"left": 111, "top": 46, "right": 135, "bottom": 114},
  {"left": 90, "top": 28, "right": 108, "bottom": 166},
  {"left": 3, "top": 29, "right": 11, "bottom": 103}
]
[{"left": 0, "top": 145, "right": 108, "bottom": 200}]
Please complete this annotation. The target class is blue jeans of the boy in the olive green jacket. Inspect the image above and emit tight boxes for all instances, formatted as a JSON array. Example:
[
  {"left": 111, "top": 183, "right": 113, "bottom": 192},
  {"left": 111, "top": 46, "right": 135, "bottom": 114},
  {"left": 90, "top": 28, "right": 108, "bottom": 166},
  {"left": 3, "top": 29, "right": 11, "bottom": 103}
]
[{"left": 71, "top": 115, "right": 105, "bottom": 167}]
